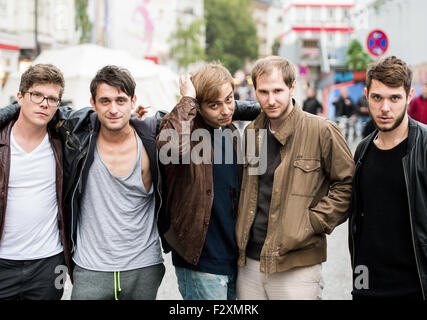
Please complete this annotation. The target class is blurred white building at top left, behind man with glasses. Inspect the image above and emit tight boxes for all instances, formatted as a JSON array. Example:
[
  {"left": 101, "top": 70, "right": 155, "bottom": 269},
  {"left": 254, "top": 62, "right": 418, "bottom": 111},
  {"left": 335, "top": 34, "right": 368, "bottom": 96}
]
[{"left": 0, "top": 0, "right": 78, "bottom": 89}]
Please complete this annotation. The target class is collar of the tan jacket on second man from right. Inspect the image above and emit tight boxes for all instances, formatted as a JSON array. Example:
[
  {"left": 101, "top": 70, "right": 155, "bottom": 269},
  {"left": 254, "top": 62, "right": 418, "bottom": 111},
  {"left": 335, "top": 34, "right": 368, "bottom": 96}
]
[{"left": 254, "top": 98, "right": 303, "bottom": 145}]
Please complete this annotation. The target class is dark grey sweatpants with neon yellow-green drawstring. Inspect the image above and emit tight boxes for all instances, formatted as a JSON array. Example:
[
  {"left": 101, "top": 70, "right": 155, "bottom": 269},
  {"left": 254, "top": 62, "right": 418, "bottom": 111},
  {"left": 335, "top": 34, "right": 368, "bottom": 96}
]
[{"left": 71, "top": 264, "right": 165, "bottom": 300}]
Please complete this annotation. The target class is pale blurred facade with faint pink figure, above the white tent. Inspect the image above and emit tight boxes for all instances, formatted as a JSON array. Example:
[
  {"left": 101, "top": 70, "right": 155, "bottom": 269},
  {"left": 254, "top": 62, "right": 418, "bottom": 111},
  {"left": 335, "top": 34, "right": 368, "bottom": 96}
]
[{"left": 88, "top": 0, "right": 204, "bottom": 63}]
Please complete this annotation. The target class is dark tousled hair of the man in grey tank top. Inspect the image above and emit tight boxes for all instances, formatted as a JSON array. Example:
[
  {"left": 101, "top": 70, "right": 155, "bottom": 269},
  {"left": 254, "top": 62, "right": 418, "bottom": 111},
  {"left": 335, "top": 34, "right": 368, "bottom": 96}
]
[{"left": 90, "top": 65, "right": 136, "bottom": 101}]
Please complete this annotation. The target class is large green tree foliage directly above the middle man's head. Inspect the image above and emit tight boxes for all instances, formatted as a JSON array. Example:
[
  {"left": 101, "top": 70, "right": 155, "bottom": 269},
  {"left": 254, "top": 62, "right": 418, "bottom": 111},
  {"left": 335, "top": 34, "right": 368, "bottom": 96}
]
[{"left": 205, "top": 0, "right": 258, "bottom": 73}]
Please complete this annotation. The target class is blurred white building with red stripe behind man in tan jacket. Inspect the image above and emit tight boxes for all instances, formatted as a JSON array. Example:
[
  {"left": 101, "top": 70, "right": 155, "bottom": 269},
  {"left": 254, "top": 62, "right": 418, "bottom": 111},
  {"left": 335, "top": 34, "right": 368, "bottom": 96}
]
[{"left": 280, "top": 0, "right": 354, "bottom": 86}]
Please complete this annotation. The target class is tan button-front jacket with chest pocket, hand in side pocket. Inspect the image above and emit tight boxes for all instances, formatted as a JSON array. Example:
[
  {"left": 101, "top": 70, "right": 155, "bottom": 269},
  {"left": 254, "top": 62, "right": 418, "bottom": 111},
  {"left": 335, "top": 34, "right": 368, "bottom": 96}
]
[{"left": 236, "top": 101, "right": 354, "bottom": 273}]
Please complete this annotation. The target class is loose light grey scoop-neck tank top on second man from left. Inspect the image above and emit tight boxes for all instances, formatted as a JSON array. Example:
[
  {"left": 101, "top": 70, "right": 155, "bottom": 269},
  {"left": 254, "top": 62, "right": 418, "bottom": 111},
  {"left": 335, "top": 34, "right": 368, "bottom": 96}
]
[{"left": 73, "top": 131, "right": 163, "bottom": 272}]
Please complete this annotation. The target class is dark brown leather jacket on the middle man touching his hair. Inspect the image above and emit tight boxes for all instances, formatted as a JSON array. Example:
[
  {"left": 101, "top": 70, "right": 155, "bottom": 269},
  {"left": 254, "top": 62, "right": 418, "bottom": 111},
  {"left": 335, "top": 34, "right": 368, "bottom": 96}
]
[{"left": 157, "top": 97, "right": 242, "bottom": 265}]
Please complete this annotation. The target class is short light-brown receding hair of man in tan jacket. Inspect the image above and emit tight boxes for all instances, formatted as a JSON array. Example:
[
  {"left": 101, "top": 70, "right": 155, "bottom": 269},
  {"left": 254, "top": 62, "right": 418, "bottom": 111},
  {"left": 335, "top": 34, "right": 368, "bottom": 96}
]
[{"left": 251, "top": 56, "right": 295, "bottom": 89}]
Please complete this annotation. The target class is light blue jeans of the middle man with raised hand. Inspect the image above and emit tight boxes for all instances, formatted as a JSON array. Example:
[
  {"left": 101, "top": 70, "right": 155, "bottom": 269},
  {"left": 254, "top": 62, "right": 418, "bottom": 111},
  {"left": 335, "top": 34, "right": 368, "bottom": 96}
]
[{"left": 175, "top": 267, "right": 236, "bottom": 300}]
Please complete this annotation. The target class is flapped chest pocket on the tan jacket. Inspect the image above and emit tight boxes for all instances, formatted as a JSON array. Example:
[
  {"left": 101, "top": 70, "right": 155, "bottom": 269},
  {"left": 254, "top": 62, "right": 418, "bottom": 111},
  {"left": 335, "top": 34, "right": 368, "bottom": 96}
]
[{"left": 291, "top": 159, "right": 321, "bottom": 197}]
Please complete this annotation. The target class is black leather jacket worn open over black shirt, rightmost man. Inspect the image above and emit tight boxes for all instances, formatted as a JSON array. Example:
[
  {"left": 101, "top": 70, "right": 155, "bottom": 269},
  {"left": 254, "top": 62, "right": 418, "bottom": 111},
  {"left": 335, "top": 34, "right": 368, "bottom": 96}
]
[{"left": 349, "top": 118, "right": 427, "bottom": 300}]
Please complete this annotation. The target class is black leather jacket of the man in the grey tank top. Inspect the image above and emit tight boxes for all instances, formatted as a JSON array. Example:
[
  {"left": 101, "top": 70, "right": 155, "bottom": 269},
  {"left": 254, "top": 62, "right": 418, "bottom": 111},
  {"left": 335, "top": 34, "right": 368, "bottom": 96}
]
[{"left": 0, "top": 101, "right": 261, "bottom": 252}]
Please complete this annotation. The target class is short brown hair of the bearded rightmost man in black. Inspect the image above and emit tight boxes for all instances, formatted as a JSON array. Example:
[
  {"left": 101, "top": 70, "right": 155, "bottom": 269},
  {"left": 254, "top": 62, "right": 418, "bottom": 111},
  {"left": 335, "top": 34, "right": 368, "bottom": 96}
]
[{"left": 365, "top": 56, "right": 412, "bottom": 95}]
